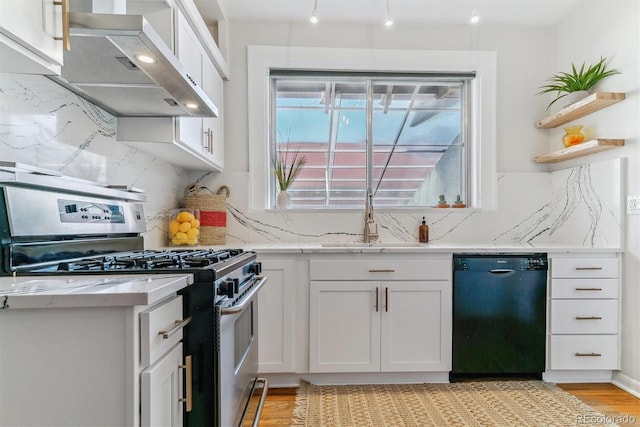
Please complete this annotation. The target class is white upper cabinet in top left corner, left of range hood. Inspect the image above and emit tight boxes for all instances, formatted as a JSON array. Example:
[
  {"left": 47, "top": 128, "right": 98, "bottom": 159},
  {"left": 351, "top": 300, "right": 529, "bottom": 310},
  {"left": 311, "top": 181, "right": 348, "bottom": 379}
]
[{"left": 0, "top": 0, "right": 64, "bottom": 74}]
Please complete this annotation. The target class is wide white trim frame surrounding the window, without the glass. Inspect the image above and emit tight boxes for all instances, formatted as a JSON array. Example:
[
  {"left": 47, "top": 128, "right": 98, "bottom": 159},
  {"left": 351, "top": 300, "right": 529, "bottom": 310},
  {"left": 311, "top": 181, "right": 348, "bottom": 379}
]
[{"left": 247, "top": 45, "right": 497, "bottom": 211}]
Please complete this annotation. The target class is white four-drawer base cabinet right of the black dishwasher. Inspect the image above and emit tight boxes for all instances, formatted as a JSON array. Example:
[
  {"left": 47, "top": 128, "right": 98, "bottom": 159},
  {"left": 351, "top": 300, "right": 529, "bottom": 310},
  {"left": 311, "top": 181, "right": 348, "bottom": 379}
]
[{"left": 547, "top": 254, "right": 620, "bottom": 370}]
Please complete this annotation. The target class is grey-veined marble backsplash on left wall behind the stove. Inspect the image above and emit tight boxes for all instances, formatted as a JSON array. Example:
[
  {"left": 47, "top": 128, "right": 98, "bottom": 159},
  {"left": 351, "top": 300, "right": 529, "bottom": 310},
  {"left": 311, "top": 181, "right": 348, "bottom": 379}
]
[{"left": 0, "top": 73, "right": 187, "bottom": 248}]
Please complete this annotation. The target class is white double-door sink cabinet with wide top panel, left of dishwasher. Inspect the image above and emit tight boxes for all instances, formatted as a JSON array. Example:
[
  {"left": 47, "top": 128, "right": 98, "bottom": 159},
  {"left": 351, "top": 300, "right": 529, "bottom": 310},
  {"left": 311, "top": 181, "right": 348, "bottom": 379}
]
[{"left": 309, "top": 257, "right": 451, "bottom": 372}]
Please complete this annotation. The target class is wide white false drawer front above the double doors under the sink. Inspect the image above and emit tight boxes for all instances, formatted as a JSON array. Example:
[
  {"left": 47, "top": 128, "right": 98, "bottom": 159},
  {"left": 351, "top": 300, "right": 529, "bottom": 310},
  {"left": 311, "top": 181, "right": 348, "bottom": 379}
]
[{"left": 309, "top": 258, "right": 452, "bottom": 281}]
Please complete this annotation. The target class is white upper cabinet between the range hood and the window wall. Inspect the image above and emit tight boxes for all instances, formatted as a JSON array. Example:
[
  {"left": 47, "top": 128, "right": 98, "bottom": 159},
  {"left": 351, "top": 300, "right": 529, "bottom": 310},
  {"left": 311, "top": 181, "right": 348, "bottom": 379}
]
[{"left": 117, "top": 0, "right": 228, "bottom": 171}]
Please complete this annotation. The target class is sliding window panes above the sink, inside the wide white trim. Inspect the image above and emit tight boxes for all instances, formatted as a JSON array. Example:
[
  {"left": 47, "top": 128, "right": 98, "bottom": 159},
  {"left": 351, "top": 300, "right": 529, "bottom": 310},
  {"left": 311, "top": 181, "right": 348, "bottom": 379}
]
[{"left": 270, "top": 70, "right": 474, "bottom": 208}]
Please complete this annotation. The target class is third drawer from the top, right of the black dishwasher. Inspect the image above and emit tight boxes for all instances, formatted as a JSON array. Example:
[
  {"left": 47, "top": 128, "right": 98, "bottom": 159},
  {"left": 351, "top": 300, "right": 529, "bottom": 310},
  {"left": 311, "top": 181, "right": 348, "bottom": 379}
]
[{"left": 551, "top": 299, "right": 618, "bottom": 334}]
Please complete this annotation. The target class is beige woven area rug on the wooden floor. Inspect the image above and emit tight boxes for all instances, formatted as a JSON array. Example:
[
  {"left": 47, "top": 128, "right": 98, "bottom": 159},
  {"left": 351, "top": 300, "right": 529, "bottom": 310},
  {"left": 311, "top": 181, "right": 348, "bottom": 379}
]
[{"left": 291, "top": 381, "right": 613, "bottom": 427}]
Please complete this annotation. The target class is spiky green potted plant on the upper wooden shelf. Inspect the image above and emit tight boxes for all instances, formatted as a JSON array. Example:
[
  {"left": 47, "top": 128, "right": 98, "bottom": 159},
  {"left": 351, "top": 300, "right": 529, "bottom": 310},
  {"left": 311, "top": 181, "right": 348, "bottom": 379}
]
[{"left": 537, "top": 57, "right": 620, "bottom": 110}]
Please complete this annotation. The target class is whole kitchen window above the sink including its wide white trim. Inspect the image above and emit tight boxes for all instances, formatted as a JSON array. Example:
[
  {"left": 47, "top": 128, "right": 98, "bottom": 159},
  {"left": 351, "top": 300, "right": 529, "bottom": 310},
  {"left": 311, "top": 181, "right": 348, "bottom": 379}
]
[{"left": 247, "top": 46, "right": 498, "bottom": 213}]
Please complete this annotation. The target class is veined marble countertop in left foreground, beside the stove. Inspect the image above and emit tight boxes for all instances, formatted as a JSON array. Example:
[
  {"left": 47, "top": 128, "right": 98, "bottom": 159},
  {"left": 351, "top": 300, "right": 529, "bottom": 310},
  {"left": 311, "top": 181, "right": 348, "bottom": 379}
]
[{"left": 0, "top": 274, "right": 193, "bottom": 311}]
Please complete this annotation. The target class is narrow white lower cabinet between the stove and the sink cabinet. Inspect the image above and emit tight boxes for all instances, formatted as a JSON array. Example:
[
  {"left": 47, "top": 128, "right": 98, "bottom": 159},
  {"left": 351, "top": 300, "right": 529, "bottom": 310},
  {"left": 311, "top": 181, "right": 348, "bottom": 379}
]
[{"left": 258, "top": 258, "right": 296, "bottom": 373}]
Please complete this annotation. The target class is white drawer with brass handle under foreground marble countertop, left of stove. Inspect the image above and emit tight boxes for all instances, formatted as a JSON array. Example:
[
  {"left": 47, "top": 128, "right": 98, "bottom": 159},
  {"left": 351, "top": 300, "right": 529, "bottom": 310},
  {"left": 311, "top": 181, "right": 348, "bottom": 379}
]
[{"left": 140, "top": 296, "right": 183, "bottom": 366}]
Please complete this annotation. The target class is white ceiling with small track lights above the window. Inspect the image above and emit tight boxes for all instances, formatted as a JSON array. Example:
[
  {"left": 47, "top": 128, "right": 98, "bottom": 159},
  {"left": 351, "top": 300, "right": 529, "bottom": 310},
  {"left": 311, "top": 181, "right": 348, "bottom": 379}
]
[{"left": 220, "top": 0, "right": 592, "bottom": 26}]
